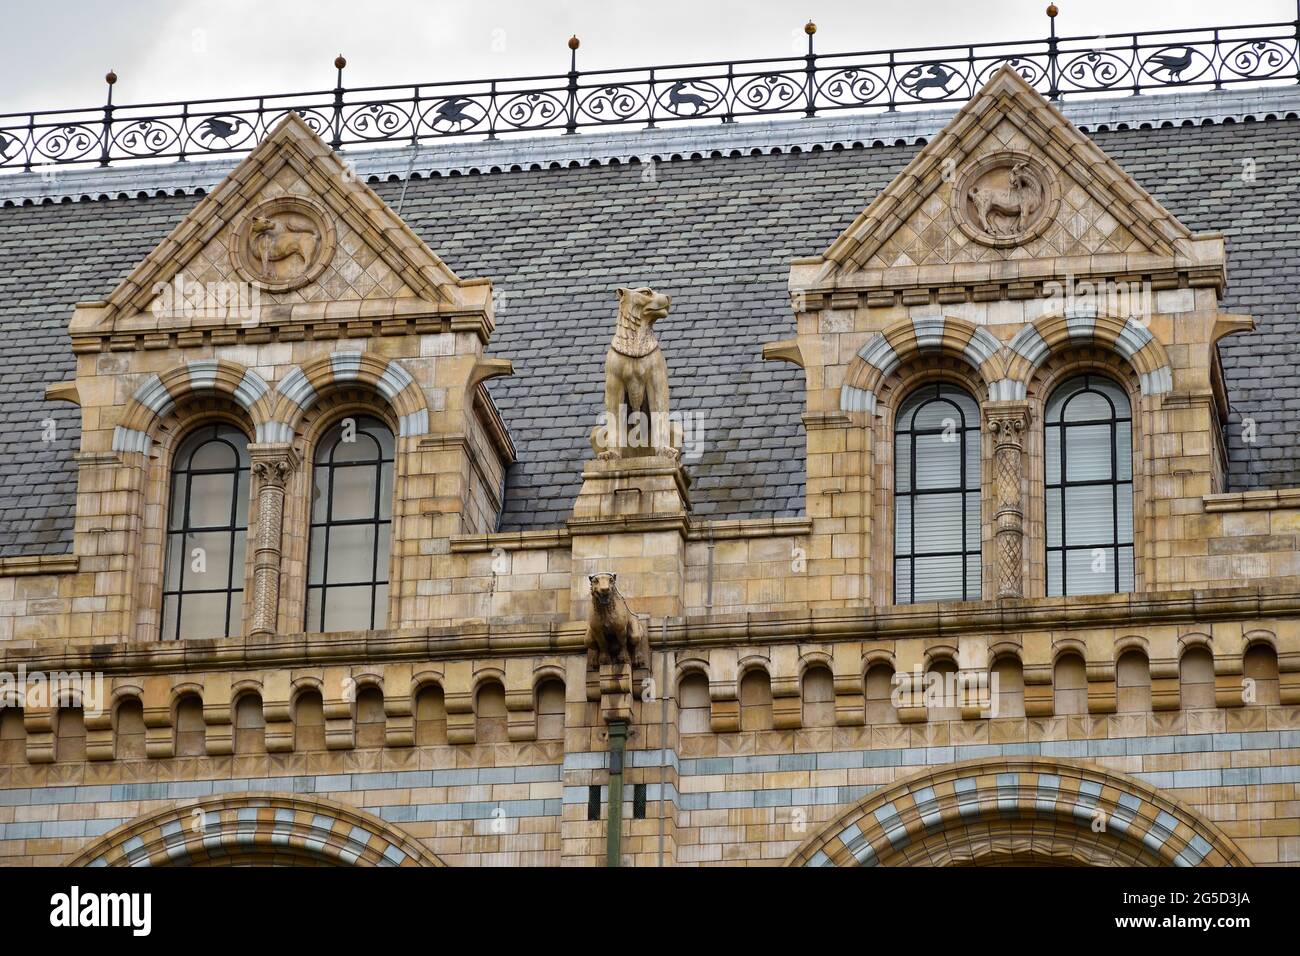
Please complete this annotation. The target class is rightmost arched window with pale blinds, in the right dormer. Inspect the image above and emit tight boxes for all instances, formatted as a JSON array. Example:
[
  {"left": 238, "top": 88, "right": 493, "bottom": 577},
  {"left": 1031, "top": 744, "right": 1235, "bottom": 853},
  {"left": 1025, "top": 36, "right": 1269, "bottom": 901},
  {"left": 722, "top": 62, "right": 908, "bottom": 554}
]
[{"left": 1043, "top": 375, "right": 1134, "bottom": 594}]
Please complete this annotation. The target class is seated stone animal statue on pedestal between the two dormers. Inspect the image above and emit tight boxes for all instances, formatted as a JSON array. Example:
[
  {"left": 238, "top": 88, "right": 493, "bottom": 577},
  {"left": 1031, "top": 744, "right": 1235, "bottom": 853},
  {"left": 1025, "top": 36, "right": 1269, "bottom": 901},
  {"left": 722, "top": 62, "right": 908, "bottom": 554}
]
[{"left": 592, "top": 286, "right": 681, "bottom": 459}]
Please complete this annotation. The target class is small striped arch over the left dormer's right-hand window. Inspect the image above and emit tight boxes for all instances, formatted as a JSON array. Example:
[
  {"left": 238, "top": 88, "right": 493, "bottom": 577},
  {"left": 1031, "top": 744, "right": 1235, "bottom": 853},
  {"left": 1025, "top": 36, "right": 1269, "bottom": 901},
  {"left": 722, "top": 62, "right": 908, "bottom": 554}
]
[{"left": 257, "top": 351, "right": 429, "bottom": 442}]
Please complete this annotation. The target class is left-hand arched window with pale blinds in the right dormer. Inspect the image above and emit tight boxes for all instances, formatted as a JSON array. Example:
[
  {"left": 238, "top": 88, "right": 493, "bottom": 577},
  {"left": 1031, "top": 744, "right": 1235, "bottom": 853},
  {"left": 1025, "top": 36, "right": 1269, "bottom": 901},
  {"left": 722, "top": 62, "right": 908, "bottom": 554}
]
[{"left": 894, "top": 382, "right": 980, "bottom": 604}]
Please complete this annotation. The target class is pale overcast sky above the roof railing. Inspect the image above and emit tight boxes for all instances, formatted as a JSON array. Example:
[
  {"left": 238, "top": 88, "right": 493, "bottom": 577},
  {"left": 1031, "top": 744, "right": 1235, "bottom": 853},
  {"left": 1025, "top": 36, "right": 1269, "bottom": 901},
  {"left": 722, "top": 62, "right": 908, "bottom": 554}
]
[{"left": 0, "top": 0, "right": 1296, "bottom": 112}]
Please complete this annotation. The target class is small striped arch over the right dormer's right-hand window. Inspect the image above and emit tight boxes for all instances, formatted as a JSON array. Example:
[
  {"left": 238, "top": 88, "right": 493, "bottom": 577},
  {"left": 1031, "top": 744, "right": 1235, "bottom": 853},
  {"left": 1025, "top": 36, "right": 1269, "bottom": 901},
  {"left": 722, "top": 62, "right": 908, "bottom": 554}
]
[{"left": 1006, "top": 307, "right": 1174, "bottom": 398}]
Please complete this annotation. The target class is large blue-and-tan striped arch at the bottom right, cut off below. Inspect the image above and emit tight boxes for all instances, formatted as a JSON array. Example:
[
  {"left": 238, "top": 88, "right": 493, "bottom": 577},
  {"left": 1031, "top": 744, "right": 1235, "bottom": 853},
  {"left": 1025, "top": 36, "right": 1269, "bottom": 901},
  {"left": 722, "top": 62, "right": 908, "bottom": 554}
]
[{"left": 785, "top": 757, "right": 1251, "bottom": 866}]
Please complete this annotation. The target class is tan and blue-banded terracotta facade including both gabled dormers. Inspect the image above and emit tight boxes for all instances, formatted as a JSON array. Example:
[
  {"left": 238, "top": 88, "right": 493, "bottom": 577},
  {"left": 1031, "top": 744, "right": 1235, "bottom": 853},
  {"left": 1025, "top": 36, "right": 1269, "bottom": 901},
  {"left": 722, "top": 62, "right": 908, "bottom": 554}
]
[{"left": 0, "top": 70, "right": 1300, "bottom": 866}]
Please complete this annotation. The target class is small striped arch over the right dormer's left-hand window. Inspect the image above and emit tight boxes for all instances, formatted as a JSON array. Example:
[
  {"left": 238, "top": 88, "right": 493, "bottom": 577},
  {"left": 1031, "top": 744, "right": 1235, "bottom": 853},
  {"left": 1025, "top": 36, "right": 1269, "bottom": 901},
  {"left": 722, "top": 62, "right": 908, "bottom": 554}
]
[{"left": 840, "top": 316, "right": 1006, "bottom": 414}]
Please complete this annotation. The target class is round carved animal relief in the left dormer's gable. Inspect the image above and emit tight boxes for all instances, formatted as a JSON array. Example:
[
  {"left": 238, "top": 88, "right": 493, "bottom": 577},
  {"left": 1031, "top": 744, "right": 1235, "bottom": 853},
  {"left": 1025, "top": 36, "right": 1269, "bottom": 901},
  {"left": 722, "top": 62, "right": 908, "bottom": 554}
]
[{"left": 230, "top": 196, "right": 335, "bottom": 293}]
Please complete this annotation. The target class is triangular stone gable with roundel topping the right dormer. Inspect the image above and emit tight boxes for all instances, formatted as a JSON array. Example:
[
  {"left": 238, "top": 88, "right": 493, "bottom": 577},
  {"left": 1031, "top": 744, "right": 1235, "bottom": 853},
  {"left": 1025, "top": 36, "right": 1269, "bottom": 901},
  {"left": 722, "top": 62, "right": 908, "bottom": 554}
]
[{"left": 814, "top": 65, "right": 1195, "bottom": 285}]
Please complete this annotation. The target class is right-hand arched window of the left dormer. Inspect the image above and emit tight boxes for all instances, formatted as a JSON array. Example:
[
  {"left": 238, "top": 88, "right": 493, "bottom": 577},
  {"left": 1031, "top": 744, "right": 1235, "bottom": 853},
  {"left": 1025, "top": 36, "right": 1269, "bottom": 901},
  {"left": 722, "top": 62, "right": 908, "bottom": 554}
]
[{"left": 307, "top": 415, "right": 393, "bottom": 632}]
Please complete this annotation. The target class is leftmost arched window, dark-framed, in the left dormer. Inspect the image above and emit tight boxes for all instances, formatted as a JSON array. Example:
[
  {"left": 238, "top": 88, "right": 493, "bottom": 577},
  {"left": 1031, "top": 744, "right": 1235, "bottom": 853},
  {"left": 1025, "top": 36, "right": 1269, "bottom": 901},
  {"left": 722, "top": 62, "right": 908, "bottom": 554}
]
[{"left": 163, "top": 424, "right": 248, "bottom": 639}]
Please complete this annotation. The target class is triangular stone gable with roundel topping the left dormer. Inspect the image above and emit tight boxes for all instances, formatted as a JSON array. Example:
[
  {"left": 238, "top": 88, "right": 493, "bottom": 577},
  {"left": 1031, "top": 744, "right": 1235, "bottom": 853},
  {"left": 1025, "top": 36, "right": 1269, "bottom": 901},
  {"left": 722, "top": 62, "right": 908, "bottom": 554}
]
[{"left": 73, "top": 112, "right": 484, "bottom": 334}]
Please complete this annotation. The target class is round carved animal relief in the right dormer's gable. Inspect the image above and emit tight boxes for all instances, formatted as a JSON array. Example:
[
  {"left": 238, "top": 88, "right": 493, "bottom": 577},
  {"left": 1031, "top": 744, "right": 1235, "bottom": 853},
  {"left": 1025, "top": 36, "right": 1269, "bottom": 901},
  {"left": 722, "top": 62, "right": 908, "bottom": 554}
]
[{"left": 953, "top": 152, "right": 1060, "bottom": 246}]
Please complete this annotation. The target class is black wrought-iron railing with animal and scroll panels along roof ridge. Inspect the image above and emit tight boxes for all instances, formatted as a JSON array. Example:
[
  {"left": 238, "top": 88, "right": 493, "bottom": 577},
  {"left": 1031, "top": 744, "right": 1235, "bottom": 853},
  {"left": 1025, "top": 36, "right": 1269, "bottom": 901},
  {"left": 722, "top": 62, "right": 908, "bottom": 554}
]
[{"left": 0, "top": 4, "right": 1300, "bottom": 170}]
